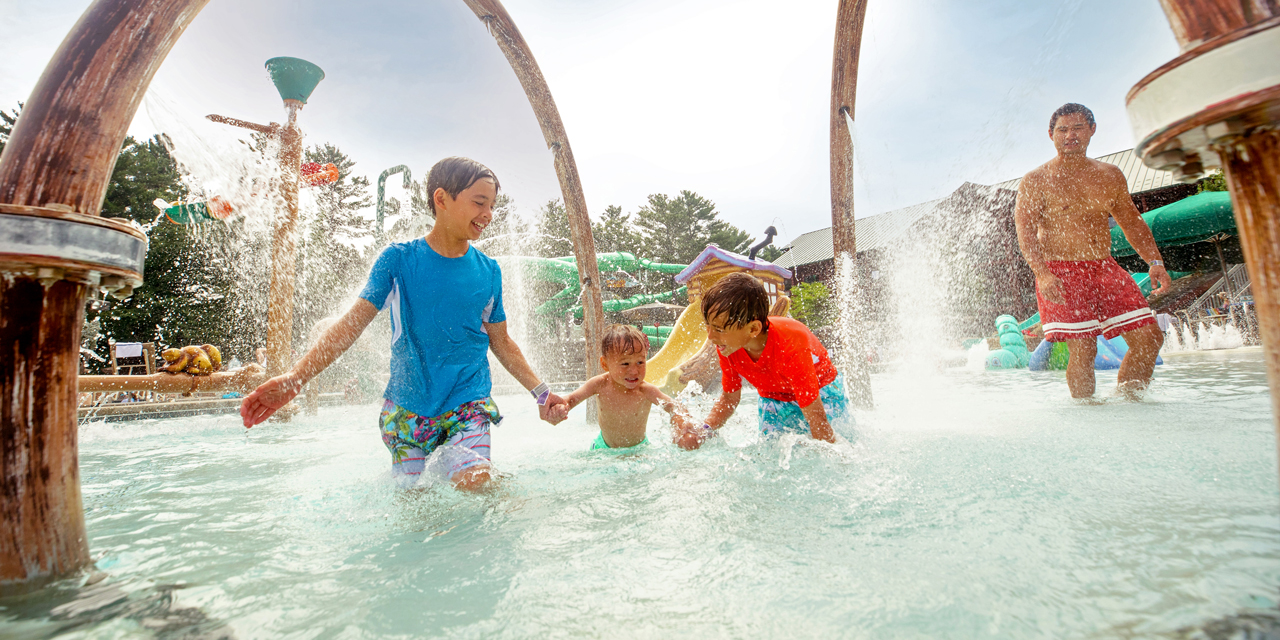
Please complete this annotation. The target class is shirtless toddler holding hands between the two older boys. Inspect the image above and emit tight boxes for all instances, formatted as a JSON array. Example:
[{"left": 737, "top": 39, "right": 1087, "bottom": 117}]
[{"left": 547, "top": 324, "right": 694, "bottom": 449}]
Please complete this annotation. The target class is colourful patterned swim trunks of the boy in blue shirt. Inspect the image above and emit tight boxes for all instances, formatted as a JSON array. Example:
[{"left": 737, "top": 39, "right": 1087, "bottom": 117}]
[{"left": 378, "top": 398, "right": 502, "bottom": 477}]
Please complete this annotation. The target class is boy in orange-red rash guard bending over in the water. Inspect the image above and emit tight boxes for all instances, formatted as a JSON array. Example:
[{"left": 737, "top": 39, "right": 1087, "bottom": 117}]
[{"left": 676, "top": 273, "right": 852, "bottom": 449}]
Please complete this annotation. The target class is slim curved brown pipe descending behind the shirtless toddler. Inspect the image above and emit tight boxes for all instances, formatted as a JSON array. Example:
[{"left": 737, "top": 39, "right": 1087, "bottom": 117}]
[{"left": 463, "top": 0, "right": 604, "bottom": 394}]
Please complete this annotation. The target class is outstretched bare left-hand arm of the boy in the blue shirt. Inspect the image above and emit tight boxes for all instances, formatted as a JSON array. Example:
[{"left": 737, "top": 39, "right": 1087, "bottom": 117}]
[{"left": 241, "top": 298, "right": 378, "bottom": 428}]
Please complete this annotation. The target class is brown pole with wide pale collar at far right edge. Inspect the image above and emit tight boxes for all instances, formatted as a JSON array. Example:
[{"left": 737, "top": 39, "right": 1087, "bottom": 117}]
[{"left": 1125, "top": 0, "right": 1280, "bottom": 468}]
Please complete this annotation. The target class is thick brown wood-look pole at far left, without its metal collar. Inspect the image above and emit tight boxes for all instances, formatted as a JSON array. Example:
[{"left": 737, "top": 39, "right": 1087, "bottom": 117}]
[{"left": 0, "top": 0, "right": 207, "bottom": 584}]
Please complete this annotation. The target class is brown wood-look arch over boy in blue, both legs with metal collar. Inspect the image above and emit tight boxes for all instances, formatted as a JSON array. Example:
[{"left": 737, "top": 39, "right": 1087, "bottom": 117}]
[{"left": 0, "top": 0, "right": 604, "bottom": 584}]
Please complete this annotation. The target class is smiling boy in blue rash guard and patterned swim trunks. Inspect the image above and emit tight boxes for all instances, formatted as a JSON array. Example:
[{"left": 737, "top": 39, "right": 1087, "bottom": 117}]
[{"left": 241, "top": 157, "right": 564, "bottom": 489}]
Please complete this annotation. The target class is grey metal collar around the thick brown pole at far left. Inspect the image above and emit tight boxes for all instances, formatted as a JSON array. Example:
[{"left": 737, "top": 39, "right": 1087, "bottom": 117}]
[{"left": 0, "top": 204, "right": 147, "bottom": 293}]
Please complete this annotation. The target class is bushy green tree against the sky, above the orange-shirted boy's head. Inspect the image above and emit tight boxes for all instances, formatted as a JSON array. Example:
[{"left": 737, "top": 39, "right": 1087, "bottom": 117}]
[{"left": 635, "top": 191, "right": 751, "bottom": 264}]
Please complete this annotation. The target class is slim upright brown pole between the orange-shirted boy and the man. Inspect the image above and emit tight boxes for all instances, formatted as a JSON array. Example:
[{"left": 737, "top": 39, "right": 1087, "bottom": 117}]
[{"left": 828, "top": 0, "right": 874, "bottom": 408}]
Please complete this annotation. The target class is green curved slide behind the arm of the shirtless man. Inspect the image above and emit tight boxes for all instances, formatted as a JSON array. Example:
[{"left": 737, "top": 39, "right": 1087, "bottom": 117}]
[{"left": 1111, "top": 191, "right": 1236, "bottom": 257}]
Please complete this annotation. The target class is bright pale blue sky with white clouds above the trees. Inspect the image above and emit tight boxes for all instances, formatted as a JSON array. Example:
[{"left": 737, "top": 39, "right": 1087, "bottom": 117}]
[{"left": 0, "top": 0, "right": 1178, "bottom": 243}]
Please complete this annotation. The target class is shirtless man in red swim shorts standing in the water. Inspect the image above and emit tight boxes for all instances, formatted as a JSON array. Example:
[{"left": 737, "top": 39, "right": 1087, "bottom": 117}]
[{"left": 1014, "top": 104, "right": 1170, "bottom": 398}]
